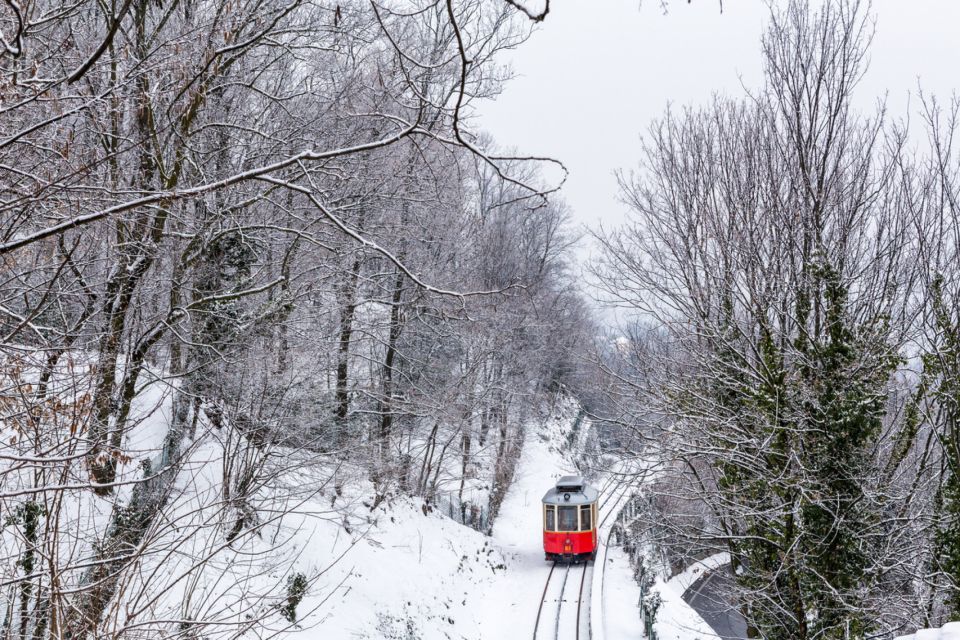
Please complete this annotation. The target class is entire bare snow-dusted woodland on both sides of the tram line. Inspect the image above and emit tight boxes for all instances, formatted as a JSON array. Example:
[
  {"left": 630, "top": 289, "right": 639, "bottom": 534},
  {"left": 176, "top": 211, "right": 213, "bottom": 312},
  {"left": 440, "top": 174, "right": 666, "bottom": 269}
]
[{"left": 0, "top": 0, "right": 960, "bottom": 640}]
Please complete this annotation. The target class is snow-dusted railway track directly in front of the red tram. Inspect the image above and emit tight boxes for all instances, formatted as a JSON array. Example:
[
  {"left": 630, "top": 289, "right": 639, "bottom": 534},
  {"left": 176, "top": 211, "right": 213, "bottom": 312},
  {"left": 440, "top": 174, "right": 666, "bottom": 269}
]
[{"left": 533, "top": 562, "right": 593, "bottom": 640}]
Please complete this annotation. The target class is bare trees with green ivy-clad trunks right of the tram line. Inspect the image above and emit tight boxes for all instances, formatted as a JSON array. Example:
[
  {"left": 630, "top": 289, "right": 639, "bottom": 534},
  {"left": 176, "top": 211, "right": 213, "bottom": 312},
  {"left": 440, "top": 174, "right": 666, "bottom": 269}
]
[{"left": 598, "top": 1, "right": 960, "bottom": 640}]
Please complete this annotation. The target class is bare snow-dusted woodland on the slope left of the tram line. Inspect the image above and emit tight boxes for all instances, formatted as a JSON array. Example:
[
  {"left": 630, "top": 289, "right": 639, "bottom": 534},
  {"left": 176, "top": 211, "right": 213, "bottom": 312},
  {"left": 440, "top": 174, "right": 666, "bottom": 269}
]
[{"left": 0, "top": 0, "right": 593, "bottom": 638}]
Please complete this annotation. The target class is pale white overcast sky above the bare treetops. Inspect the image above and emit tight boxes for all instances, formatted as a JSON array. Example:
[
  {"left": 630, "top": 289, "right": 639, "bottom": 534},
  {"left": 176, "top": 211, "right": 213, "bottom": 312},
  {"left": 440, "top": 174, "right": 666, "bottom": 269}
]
[{"left": 476, "top": 0, "right": 960, "bottom": 249}]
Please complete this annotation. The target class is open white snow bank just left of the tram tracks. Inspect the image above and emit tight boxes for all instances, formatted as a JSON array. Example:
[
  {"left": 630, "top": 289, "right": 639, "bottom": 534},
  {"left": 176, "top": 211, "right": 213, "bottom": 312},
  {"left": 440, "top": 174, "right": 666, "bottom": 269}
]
[{"left": 299, "top": 488, "right": 506, "bottom": 640}]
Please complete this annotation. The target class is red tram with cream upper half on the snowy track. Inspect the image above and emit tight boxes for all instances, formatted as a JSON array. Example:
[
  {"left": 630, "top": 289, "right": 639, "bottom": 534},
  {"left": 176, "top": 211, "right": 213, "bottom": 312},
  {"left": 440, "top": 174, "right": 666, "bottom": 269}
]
[{"left": 543, "top": 476, "right": 600, "bottom": 562}]
